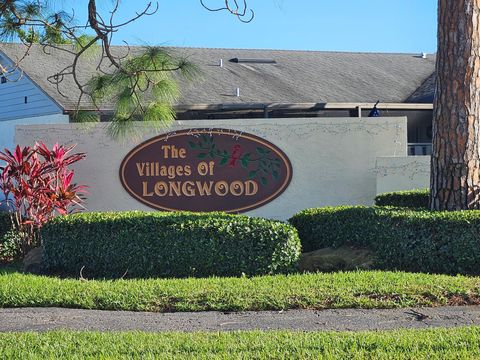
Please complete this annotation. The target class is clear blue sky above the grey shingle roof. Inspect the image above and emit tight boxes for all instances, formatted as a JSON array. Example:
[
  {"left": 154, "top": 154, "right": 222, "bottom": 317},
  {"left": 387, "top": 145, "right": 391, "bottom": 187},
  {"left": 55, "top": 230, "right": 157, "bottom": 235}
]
[{"left": 58, "top": 0, "right": 437, "bottom": 53}]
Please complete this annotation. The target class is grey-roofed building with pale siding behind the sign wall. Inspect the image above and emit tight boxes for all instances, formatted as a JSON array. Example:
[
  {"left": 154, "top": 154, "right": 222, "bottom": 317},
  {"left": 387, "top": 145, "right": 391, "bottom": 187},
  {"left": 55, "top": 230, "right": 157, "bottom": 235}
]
[{"left": 0, "top": 43, "right": 435, "bottom": 155}]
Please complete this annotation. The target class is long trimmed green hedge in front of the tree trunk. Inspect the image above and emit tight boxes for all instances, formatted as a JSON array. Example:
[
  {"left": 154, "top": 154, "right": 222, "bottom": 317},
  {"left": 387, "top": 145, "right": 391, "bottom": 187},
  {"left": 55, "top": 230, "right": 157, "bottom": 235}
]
[{"left": 290, "top": 206, "right": 480, "bottom": 275}]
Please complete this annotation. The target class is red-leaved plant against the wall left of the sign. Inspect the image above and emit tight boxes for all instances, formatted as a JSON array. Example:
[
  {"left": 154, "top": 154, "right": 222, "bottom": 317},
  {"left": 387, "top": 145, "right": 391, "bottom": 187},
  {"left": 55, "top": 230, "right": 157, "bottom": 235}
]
[{"left": 0, "top": 143, "right": 85, "bottom": 255}]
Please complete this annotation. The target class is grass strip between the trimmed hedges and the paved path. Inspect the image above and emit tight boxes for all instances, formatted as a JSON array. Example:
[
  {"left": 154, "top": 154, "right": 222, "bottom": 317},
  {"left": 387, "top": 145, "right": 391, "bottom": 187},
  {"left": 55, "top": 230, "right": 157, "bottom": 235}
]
[{"left": 0, "top": 269, "right": 480, "bottom": 312}]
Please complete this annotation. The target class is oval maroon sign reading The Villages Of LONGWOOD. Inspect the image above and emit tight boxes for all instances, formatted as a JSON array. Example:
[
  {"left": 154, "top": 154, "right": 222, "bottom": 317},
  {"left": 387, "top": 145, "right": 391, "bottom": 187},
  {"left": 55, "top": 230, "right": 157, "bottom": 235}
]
[{"left": 120, "top": 129, "right": 292, "bottom": 213}]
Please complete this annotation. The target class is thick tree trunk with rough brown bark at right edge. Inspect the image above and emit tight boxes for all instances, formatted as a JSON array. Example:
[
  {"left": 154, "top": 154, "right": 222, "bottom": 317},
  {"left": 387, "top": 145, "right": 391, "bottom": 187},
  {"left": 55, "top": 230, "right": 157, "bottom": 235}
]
[{"left": 430, "top": 0, "right": 480, "bottom": 210}]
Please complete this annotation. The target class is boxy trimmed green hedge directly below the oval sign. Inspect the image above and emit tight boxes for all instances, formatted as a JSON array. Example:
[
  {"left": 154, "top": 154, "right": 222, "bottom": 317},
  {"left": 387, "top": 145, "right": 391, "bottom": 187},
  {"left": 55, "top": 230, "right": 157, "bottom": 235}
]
[{"left": 42, "top": 212, "right": 300, "bottom": 278}]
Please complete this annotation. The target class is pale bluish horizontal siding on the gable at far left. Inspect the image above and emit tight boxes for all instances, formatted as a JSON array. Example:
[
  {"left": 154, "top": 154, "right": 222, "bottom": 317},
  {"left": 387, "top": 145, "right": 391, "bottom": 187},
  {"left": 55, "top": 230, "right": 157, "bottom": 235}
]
[{"left": 0, "top": 56, "right": 62, "bottom": 121}]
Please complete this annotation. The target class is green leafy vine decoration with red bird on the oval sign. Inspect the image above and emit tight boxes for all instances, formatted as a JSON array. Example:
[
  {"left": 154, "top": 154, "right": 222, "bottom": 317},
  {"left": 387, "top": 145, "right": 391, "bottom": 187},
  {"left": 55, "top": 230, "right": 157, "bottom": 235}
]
[{"left": 188, "top": 135, "right": 281, "bottom": 186}]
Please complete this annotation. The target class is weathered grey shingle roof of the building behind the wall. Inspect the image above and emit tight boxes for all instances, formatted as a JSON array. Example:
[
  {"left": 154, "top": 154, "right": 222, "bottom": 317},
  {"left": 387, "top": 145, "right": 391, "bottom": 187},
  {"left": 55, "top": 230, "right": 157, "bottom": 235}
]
[{"left": 0, "top": 43, "right": 435, "bottom": 110}]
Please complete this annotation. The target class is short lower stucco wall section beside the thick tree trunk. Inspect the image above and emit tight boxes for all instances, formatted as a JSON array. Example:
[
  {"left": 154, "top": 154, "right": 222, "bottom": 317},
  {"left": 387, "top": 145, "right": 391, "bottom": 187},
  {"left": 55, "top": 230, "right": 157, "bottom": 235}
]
[{"left": 376, "top": 156, "right": 430, "bottom": 194}]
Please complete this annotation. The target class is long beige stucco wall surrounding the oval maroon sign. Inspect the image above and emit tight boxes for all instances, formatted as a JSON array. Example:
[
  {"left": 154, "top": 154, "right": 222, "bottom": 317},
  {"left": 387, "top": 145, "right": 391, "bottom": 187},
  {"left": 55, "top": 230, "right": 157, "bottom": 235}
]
[{"left": 16, "top": 118, "right": 407, "bottom": 219}]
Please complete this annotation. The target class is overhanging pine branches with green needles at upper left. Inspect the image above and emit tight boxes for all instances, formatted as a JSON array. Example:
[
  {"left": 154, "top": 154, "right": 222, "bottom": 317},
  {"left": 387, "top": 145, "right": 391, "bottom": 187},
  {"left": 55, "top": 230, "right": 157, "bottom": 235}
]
[{"left": 0, "top": 0, "right": 255, "bottom": 136}]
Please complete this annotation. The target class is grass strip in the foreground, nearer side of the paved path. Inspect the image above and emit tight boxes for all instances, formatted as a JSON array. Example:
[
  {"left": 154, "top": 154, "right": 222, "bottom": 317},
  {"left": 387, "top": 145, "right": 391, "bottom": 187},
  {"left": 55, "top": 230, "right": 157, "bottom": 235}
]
[{"left": 0, "top": 327, "right": 480, "bottom": 360}]
